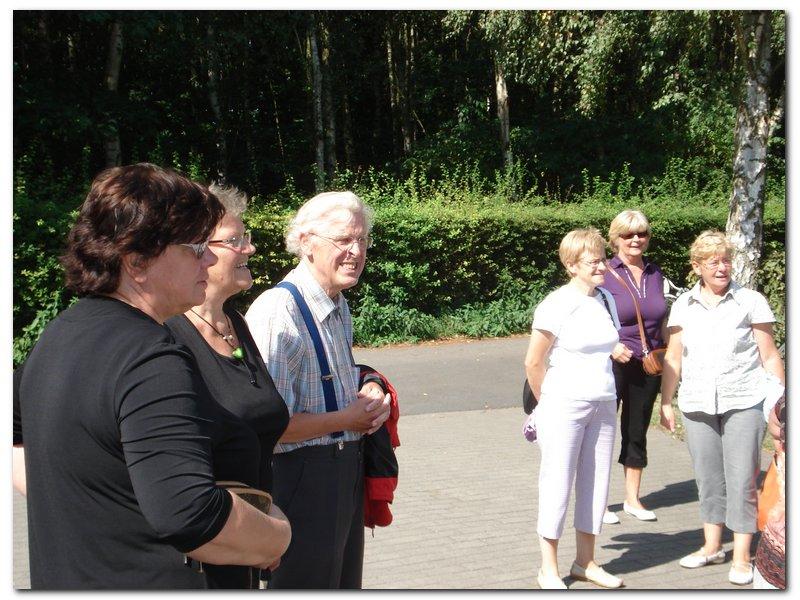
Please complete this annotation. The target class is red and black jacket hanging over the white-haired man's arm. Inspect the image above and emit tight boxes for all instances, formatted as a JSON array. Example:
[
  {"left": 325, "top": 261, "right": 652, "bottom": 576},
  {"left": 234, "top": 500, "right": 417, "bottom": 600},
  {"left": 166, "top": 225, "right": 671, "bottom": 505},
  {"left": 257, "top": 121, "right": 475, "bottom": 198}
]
[{"left": 358, "top": 365, "right": 400, "bottom": 529}]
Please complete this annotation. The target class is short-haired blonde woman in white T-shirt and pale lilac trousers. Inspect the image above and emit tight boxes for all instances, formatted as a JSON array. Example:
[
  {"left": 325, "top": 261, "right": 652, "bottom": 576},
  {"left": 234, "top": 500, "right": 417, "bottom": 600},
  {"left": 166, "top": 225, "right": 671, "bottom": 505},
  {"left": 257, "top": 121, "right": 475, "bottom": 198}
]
[{"left": 525, "top": 228, "right": 622, "bottom": 589}]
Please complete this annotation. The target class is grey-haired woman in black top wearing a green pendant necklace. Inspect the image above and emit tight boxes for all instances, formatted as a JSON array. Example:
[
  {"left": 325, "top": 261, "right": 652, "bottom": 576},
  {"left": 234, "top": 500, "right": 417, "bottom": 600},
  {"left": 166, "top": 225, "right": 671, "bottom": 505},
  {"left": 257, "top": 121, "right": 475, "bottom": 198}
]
[{"left": 167, "top": 184, "right": 289, "bottom": 589}]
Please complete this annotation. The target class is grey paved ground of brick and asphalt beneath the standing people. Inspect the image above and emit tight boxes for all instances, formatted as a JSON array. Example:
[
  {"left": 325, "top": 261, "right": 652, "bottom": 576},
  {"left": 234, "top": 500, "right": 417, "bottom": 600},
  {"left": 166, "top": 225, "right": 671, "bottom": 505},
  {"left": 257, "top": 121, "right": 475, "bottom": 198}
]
[{"left": 14, "top": 337, "right": 766, "bottom": 590}]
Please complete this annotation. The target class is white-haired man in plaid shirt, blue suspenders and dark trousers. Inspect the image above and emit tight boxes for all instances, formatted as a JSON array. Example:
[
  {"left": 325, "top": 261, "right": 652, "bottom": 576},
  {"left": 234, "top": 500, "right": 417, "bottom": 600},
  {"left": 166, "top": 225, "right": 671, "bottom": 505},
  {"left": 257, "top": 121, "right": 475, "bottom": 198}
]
[{"left": 246, "top": 192, "right": 390, "bottom": 589}]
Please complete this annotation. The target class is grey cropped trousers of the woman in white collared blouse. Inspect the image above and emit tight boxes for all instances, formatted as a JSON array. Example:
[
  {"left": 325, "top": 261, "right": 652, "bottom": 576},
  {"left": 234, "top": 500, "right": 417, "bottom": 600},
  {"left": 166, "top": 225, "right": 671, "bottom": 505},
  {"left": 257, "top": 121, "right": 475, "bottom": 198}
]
[{"left": 683, "top": 402, "right": 766, "bottom": 533}]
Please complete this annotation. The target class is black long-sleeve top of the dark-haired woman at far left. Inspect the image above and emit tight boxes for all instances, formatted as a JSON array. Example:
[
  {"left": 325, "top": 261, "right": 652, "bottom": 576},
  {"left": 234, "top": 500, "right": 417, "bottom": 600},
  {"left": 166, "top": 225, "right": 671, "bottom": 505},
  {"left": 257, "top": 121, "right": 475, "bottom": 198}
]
[{"left": 14, "top": 297, "right": 247, "bottom": 589}]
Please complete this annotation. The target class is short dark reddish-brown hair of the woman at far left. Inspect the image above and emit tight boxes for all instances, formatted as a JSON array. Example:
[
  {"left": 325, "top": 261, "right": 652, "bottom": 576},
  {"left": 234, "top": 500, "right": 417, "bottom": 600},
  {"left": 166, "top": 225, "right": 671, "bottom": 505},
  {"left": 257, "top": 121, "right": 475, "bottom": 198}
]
[{"left": 61, "top": 163, "right": 225, "bottom": 296}]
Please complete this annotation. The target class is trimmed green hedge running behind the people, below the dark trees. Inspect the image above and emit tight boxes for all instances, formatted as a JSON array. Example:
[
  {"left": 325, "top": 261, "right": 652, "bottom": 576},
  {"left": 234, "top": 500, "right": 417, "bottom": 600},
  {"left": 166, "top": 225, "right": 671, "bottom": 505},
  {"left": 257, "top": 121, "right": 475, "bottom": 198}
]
[{"left": 14, "top": 182, "right": 786, "bottom": 364}]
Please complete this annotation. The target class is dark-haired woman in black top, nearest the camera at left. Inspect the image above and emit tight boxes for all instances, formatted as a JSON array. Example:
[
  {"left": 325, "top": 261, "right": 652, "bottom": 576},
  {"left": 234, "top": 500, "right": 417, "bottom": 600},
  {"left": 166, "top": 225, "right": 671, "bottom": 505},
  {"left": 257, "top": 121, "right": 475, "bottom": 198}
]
[{"left": 13, "top": 164, "right": 291, "bottom": 589}]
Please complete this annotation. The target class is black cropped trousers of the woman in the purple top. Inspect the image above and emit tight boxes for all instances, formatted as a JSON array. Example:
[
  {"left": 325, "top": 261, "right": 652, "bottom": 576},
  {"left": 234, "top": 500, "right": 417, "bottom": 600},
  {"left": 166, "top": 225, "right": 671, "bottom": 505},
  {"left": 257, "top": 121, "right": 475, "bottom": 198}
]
[{"left": 613, "top": 358, "right": 661, "bottom": 469}]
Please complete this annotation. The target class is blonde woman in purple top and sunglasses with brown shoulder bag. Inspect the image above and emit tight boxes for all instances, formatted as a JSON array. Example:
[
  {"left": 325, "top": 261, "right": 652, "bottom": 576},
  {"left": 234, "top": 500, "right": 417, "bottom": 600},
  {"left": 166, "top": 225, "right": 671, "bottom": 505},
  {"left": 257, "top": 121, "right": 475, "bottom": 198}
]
[{"left": 603, "top": 210, "right": 667, "bottom": 523}]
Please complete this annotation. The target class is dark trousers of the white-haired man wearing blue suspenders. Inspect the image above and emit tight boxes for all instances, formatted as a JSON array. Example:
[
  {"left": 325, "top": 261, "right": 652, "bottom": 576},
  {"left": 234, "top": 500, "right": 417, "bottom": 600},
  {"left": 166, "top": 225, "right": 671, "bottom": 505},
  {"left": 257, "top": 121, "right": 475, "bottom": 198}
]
[{"left": 269, "top": 441, "right": 364, "bottom": 589}]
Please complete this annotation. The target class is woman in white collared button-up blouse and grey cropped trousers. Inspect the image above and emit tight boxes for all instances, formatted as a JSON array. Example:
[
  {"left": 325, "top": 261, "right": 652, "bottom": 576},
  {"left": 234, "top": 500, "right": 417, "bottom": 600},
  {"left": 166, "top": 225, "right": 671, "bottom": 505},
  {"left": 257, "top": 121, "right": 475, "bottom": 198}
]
[{"left": 661, "top": 231, "right": 784, "bottom": 585}]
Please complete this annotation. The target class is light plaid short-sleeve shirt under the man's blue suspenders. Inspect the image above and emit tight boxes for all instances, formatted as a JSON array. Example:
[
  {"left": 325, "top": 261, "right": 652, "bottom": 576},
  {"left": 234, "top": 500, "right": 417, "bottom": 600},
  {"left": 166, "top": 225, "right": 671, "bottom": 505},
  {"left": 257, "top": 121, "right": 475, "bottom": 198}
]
[{"left": 245, "top": 262, "right": 362, "bottom": 454}]
